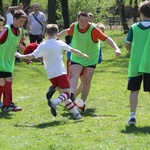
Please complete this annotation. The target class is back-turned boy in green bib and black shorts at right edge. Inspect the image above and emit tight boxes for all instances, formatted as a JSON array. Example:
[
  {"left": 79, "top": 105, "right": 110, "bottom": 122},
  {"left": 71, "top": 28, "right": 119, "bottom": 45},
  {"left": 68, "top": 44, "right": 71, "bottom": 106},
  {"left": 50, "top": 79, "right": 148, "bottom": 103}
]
[{"left": 125, "top": 1, "right": 150, "bottom": 125}]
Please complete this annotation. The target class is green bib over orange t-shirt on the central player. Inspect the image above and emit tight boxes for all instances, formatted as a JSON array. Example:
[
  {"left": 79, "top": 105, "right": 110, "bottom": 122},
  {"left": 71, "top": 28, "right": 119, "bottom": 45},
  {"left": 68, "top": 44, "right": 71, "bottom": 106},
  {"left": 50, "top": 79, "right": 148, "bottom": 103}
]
[{"left": 68, "top": 22, "right": 107, "bottom": 66}]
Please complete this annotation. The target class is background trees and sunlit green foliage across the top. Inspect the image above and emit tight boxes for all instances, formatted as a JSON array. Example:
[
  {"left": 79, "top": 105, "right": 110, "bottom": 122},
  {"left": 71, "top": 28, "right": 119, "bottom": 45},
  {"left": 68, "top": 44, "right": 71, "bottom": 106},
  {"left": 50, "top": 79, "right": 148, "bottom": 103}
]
[{"left": 0, "top": 0, "right": 147, "bottom": 33}]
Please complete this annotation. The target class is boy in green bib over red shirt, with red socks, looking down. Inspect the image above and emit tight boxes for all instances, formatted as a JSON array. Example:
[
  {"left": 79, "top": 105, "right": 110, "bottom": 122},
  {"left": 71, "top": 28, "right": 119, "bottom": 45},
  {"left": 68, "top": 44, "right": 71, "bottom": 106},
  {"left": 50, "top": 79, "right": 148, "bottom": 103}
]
[{"left": 0, "top": 10, "right": 27, "bottom": 111}]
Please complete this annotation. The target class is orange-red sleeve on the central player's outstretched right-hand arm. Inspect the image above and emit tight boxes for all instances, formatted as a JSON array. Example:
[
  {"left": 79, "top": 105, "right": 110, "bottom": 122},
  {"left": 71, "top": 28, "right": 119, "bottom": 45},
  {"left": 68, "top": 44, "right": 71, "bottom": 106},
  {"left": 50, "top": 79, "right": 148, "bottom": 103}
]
[{"left": 92, "top": 28, "right": 108, "bottom": 42}]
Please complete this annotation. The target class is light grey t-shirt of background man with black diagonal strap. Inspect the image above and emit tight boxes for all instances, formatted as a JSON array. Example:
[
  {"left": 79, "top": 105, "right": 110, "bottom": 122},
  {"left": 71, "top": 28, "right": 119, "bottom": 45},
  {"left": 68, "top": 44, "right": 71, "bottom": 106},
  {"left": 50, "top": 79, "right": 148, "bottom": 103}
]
[{"left": 28, "top": 11, "right": 46, "bottom": 35}]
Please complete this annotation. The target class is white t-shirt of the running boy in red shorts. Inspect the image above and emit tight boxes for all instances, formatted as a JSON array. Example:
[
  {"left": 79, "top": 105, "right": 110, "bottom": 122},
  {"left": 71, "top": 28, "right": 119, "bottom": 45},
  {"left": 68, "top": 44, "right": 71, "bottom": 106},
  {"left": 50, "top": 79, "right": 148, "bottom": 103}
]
[{"left": 32, "top": 39, "right": 72, "bottom": 79}]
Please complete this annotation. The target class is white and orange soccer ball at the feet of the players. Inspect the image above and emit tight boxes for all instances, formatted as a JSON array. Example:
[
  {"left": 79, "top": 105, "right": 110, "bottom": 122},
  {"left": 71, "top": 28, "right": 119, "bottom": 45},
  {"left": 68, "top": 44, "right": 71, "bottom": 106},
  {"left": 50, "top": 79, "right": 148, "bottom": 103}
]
[{"left": 74, "top": 99, "right": 86, "bottom": 113}]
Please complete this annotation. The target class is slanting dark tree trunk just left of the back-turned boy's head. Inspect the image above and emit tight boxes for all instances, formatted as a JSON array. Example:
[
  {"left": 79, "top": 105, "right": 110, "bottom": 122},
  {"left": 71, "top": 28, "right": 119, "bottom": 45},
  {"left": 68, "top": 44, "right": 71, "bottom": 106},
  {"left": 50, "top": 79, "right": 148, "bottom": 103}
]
[{"left": 116, "top": 0, "right": 129, "bottom": 34}]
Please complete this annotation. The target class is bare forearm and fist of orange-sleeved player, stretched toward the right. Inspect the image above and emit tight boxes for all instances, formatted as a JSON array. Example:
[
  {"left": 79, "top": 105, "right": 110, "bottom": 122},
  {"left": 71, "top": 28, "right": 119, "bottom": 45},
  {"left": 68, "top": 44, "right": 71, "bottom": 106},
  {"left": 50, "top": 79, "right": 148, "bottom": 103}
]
[{"left": 106, "top": 37, "right": 121, "bottom": 56}]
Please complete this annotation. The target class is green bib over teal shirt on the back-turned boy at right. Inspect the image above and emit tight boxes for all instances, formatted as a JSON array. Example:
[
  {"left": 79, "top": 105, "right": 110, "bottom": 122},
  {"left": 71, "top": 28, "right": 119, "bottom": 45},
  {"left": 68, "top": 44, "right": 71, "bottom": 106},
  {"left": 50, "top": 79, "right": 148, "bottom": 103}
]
[{"left": 126, "top": 21, "right": 150, "bottom": 77}]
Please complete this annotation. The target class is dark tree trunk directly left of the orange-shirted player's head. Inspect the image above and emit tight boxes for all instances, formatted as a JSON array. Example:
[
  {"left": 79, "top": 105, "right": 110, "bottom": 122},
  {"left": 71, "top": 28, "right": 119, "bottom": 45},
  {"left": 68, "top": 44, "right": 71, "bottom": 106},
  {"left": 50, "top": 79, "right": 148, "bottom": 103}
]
[{"left": 61, "top": 0, "right": 71, "bottom": 44}]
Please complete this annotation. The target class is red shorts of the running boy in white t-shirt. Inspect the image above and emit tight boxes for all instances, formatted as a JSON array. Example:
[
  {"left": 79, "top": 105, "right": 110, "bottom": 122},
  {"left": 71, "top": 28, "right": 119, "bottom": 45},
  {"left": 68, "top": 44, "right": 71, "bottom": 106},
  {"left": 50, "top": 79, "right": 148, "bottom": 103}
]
[{"left": 50, "top": 74, "right": 70, "bottom": 89}]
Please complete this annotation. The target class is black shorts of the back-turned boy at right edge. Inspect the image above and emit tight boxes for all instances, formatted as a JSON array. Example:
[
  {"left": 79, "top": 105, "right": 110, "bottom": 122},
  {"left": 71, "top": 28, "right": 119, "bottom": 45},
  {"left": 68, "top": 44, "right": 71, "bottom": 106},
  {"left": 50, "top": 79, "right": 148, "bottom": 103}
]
[{"left": 127, "top": 73, "right": 150, "bottom": 92}]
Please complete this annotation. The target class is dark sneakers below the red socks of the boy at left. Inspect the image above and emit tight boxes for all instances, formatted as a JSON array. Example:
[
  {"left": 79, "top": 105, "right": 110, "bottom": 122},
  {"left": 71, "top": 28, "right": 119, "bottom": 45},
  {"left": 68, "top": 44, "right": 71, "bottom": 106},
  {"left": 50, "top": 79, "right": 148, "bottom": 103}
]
[{"left": 2, "top": 103, "right": 22, "bottom": 112}]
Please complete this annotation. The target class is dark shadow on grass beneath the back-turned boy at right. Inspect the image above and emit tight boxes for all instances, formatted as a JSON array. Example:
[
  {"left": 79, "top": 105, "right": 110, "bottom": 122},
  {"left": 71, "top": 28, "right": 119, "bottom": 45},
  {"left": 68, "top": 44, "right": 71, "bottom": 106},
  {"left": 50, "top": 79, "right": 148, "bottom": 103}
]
[{"left": 121, "top": 126, "right": 150, "bottom": 134}]
